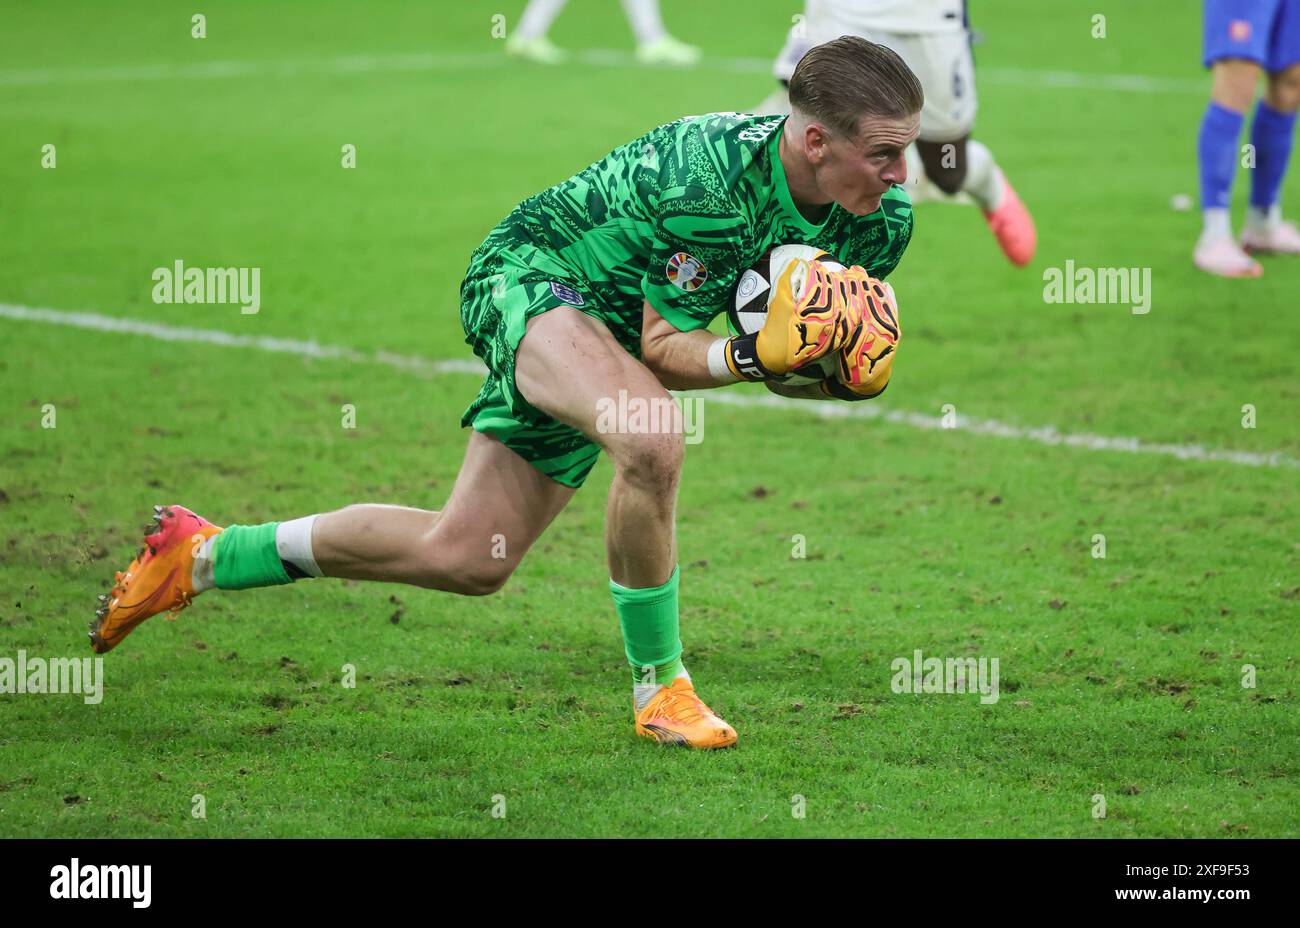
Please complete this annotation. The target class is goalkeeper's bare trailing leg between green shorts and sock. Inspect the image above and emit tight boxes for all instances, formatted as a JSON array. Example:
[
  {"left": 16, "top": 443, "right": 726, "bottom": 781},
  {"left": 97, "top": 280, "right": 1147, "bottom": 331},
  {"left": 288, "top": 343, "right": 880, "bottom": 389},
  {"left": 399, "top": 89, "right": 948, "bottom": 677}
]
[{"left": 312, "top": 432, "right": 575, "bottom": 594}]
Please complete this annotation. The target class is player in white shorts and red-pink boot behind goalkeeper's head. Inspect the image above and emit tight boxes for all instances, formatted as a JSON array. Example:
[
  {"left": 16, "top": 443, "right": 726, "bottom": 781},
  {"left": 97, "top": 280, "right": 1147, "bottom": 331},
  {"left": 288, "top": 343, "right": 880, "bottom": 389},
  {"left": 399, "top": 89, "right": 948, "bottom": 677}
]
[{"left": 759, "top": 0, "right": 1037, "bottom": 266}]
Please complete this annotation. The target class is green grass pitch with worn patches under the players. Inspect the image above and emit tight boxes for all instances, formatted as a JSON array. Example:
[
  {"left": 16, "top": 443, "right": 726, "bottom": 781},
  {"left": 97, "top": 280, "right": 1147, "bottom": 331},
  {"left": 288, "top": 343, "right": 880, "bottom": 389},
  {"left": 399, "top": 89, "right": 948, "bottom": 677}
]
[{"left": 0, "top": 0, "right": 1300, "bottom": 837}]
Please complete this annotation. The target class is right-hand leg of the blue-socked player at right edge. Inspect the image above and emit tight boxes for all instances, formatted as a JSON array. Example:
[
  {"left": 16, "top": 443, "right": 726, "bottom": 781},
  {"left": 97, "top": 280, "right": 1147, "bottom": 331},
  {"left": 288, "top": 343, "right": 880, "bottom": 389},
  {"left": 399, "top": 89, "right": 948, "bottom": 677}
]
[{"left": 1242, "top": 62, "right": 1300, "bottom": 255}]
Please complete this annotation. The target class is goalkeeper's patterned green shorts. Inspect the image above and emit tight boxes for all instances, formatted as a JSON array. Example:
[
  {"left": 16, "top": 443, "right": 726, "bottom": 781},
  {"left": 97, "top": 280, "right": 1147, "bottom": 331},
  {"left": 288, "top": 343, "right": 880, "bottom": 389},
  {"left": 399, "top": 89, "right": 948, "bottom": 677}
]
[{"left": 460, "top": 237, "right": 603, "bottom": 487}]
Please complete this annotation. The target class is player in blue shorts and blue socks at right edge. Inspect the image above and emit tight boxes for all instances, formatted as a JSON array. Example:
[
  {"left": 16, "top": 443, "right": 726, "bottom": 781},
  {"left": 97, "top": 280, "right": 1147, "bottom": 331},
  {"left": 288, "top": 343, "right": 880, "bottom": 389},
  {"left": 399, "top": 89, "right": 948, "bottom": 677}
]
[{"left": 1192, "top": 0, "right": 1300, "bottom": 277}]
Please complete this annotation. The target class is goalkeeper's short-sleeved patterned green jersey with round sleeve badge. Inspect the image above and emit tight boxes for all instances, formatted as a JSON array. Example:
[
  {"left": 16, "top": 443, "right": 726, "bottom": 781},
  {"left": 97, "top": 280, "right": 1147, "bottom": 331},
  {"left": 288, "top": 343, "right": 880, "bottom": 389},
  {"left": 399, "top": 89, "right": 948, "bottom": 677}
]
[{"left": 467, "top": 113, "right": 913, "bottom": 356}]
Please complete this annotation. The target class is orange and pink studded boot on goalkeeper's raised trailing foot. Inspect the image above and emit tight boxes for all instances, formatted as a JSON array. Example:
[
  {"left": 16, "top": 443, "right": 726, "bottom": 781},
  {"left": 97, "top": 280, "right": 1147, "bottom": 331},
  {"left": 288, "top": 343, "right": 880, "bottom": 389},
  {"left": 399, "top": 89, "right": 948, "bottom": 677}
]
[{"left": 90, "top": 506, "right": 221, "bottom": 654}]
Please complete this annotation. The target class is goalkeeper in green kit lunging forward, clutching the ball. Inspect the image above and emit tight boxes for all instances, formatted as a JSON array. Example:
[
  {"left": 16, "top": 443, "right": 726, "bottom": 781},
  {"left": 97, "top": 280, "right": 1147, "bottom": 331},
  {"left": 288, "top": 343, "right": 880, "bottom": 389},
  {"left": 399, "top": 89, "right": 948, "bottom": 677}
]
[{"left": 91, "top": 36, "right": 923, "bottom": 747}]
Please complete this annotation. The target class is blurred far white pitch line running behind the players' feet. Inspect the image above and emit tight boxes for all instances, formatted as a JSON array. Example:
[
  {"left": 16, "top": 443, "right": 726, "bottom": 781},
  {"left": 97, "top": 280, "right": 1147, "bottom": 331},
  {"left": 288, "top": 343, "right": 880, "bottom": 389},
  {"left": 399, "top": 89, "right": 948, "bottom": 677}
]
[{"left": 0, "top": 48, "right": 1209, "bottom": 96}]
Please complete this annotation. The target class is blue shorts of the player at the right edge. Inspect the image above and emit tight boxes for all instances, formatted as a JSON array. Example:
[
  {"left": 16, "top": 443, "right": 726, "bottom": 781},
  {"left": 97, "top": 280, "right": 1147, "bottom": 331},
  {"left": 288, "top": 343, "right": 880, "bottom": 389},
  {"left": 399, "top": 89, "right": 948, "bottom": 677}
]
[{"left": 1205, "top": 0, "right": 1300, "bottom": 74}]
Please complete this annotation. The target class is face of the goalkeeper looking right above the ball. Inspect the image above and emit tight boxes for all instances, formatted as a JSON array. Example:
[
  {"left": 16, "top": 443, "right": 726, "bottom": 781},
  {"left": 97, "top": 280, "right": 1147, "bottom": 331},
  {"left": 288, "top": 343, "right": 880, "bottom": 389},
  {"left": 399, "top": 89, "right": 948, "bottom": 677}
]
[{"left": 815, "top": 113, "right": 920, "bottom": 216}]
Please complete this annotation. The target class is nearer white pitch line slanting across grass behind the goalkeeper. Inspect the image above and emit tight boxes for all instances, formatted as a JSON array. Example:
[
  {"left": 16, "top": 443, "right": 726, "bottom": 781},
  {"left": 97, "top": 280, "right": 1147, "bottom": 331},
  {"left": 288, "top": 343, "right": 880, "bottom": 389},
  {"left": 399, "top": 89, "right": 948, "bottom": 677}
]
[{"left": 0, "top": 303, "right": 1300, "bottom": 469}]
